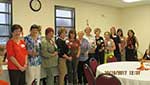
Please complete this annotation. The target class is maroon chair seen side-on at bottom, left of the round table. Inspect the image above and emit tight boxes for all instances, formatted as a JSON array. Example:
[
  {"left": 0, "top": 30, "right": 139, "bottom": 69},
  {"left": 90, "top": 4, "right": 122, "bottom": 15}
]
[{"left": 83, "top": 64, "right": 95, "bottom": 85}]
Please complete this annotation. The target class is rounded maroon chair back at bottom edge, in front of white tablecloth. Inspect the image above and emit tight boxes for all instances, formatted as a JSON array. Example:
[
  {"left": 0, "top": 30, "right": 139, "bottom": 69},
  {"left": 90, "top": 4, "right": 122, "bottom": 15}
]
[{"left": 95, "top": 73, "right": 121, "bottom": 85}]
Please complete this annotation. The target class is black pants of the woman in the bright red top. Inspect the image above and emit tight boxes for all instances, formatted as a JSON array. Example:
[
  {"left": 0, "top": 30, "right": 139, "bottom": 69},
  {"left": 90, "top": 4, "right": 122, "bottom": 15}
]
[{"left": 9, "top": 70, "right": 25, "bottom": 85}]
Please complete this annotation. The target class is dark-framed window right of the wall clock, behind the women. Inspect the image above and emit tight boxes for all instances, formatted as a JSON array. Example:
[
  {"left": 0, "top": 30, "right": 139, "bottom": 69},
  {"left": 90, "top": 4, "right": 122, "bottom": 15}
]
[{"left": 55, "top": 6, "right": 75, "bottom": 34}]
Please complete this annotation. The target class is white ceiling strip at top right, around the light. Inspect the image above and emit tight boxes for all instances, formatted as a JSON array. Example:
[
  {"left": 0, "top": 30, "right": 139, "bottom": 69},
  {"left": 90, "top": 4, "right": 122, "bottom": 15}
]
[{"left": 80, "top": 0, "right": 150, "bottom": 8}]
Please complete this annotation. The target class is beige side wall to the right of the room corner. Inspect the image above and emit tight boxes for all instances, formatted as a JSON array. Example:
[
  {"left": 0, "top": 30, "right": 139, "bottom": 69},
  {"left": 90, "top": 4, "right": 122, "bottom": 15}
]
[{"left": 121, "top": 5, "right": 150, "bottom": 53}]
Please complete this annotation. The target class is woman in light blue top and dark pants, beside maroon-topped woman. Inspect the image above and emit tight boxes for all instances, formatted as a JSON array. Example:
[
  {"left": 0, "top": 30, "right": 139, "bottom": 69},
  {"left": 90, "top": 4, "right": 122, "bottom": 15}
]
[{"left": 77, "top": 31, "right": 90, "bottom": 85}]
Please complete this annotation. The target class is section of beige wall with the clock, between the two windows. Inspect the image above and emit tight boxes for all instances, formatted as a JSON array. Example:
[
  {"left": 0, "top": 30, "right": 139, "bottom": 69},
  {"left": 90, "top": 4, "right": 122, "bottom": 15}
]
[{"left": 13, "top": 0, "right": 54, "bottom": 35}]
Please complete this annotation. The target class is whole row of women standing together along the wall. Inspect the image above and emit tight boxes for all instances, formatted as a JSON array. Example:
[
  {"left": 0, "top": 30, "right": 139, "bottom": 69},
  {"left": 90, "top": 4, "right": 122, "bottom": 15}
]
[{"left": 6, "top": 24, "right": 139, "bottom": 85}]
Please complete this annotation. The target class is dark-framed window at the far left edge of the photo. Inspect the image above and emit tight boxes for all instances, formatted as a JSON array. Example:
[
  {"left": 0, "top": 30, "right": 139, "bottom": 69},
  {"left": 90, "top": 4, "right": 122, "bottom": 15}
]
[{"left": 0, "top": 0, "right": 12, "bottom": 45}]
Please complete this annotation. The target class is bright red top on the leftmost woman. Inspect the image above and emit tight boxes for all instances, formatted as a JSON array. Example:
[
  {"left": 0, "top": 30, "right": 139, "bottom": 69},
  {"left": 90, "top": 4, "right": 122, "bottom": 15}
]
[{"left": 6, "top": 39, "right": 27, "bottom": 70}]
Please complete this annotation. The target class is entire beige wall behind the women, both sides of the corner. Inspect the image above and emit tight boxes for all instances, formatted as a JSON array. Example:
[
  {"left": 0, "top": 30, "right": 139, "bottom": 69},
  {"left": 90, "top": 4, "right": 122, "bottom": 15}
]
[{"left": 13, "top": 0, "right": 150, "bottom": 52}]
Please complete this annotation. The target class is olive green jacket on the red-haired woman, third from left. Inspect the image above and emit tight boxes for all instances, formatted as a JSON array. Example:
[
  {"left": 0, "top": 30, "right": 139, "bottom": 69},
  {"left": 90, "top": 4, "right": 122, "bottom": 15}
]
[{"left": 41, "top": 38, "right": 58, "bottom": 68}]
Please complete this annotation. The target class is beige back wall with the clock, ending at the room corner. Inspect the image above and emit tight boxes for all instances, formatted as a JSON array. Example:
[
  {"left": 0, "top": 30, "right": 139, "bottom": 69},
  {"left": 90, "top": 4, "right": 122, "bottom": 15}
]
[{"left": 13, "top": 0, "right": 120, "bottom": 35}]
